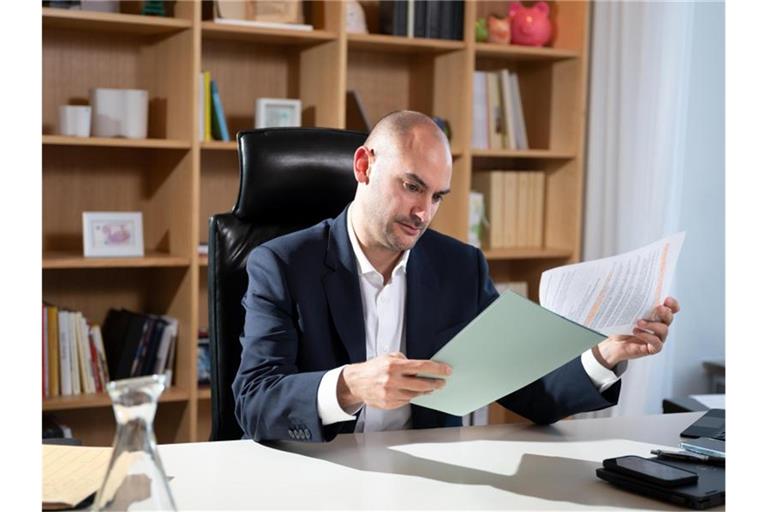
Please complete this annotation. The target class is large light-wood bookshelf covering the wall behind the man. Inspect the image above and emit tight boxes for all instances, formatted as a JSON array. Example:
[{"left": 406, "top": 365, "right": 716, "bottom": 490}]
[{"left": 42, "top": 0, "right": 590, "bottom": 445}]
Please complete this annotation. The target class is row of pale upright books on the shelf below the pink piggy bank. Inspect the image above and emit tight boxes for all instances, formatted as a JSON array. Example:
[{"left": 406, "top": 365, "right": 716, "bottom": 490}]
[{"left": 472, "top": 69, "right": 528, "bottom": 150}]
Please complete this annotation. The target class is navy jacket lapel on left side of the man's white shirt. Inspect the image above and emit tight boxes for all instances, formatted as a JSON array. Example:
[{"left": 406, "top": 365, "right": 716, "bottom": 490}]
[{"left": 323, "top": 207, "right": 366, "bottom": 363}]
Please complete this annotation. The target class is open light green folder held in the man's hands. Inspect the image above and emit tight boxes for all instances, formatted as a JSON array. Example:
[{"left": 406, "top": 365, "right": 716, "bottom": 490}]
[{"left": 411, "top": 291, "right": 606, "bottom": 416}]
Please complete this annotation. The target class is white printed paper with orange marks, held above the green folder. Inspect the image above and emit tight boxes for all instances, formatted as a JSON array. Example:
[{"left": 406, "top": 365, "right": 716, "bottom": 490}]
[{"left": 539, "top": 232, "right": 685, "bottom": 336}]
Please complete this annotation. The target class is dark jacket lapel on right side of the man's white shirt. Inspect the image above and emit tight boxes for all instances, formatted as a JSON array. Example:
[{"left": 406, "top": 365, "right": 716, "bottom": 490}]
[{"left": 405, "top": 242, "right": 439, "bottom": 359}]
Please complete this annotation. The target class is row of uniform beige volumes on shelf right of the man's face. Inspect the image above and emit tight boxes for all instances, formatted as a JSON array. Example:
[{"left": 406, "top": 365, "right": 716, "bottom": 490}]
[{"left": 472, "top": 171, "right": 545, "bottom": 249}]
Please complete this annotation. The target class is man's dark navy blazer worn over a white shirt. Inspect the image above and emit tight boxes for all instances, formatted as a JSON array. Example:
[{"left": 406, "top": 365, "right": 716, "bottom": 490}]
[{"left": 232, "top": 208, "right": 621, "bottom": 441}]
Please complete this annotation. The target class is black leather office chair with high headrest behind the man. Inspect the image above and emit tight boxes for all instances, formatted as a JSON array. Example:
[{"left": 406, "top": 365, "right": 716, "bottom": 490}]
[{"left": 208, "top": 128, "right": 366, "bottom": 441}]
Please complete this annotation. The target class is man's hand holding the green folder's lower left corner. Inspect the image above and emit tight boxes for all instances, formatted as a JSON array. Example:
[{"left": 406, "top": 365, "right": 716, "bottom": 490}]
[{"left": 336, "top": 352, "right": 451, "bottom": 411}]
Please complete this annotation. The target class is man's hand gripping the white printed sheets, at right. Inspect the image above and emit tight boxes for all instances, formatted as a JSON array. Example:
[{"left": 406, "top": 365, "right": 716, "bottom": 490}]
[{"left": 592, "top": 297, "right": 680, "bottom": 370}]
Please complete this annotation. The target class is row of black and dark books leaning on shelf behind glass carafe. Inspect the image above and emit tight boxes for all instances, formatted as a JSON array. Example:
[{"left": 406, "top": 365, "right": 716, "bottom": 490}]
[{"left": 103, "top": 309, "right": 179, "bottom": 380}]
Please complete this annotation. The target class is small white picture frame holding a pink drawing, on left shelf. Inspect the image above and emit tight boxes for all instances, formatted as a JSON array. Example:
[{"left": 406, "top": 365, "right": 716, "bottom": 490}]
[{"left": 83, "top": 212, "right": 144, "bottom": 258}]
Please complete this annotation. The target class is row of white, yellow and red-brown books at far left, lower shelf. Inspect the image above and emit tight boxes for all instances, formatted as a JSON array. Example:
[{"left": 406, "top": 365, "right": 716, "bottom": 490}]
[{"left": 43, "top": 303, "right": 109, "bottom": 398}]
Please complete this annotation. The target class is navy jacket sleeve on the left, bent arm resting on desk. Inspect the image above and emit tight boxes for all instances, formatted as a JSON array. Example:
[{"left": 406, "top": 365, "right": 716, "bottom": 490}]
[{"left": 232, "top": 246, "right": 339, "bottom": 441}]
